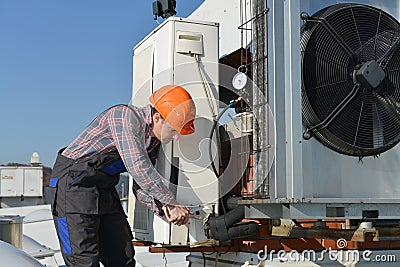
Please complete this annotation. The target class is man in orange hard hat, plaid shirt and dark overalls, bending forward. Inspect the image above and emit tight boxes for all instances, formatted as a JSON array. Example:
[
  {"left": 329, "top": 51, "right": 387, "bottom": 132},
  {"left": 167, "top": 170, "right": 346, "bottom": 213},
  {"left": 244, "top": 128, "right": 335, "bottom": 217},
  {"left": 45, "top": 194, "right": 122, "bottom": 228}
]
[{"left": 50, "top": 85, "right": 196, "bottom": 267}]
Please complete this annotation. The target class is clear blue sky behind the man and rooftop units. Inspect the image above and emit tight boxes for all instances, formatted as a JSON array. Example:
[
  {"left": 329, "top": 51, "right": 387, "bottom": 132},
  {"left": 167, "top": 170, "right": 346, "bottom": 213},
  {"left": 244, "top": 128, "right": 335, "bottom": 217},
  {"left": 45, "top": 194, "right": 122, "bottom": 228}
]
[{"left": 0, "top": 0, "right": 204, "bottom": 167}]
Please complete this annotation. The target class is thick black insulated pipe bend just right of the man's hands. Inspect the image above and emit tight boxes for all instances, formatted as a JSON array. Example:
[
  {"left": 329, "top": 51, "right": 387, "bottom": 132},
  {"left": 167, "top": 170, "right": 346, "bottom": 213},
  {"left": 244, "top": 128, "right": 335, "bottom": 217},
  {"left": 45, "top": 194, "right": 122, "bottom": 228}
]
[{"left": 209, "top": 205, "right": 259, "bottom": 241}]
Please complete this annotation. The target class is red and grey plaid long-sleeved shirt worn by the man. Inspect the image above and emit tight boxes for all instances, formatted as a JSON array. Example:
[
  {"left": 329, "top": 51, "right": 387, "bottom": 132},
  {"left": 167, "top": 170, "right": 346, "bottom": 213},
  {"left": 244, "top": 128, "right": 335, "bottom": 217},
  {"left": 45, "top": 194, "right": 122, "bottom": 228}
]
[{"left": 62, "top": 105, "right": 176, "bottom": 216}]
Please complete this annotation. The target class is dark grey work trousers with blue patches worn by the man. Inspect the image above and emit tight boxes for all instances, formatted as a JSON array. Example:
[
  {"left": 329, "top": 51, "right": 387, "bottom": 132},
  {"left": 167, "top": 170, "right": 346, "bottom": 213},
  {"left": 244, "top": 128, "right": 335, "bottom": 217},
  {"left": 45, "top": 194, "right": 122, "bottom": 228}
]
[{"left": 50, "top": 154, "right": 135, "bottom": 267}]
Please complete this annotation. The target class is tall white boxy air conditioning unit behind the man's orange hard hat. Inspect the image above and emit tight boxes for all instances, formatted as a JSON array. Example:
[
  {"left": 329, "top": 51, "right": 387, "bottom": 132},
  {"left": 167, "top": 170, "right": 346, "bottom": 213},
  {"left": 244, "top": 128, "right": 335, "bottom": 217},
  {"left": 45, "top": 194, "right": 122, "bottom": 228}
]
[{"left": 129, "top": 17, "right": 219, "bottom": 245}]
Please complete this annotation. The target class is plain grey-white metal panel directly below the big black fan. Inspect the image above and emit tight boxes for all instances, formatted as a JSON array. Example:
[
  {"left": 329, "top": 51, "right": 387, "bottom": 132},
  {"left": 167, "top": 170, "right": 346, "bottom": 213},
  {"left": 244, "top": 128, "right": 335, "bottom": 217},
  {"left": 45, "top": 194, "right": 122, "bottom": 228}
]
[{"left": 303, "top": 135, "right": 400, "bottom": 201}]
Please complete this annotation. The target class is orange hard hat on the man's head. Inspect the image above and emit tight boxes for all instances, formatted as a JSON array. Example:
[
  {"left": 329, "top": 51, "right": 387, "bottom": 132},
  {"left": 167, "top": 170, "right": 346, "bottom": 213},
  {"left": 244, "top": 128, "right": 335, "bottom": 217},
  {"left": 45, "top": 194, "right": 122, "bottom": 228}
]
[{"left": 149, "top": 84, "right": 196, "bottom": 135}]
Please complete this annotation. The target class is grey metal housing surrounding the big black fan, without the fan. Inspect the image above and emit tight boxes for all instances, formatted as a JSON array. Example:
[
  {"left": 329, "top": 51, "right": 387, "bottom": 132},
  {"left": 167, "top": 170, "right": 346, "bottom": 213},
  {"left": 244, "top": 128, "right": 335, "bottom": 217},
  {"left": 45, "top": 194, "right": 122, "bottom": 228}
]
[{"left": 248, "top": 0, "right": 400, "bottom": 219}]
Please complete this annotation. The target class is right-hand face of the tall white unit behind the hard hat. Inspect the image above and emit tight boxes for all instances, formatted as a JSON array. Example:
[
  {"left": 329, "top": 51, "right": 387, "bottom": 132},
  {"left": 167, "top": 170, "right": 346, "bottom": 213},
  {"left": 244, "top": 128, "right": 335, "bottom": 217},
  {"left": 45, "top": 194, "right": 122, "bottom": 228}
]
[{"left": 174, "top": 21, "right": 219, "bottom": 205}]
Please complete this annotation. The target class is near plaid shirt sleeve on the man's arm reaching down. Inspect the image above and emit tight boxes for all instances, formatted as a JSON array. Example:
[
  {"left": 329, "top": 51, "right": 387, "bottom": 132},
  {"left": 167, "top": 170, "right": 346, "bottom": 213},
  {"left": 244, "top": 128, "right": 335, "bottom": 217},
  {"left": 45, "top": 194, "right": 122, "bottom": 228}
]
[{"left": 107, "top": 107, "right": 175, "bottom": 213}]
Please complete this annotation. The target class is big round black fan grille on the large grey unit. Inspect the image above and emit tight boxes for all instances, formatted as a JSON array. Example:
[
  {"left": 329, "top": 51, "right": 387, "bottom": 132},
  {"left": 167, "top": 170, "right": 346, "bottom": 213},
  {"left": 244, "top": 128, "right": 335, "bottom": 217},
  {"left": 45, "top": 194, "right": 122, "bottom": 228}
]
[{"left": 301, "top": 4, "right": 400, "bottom": 157}]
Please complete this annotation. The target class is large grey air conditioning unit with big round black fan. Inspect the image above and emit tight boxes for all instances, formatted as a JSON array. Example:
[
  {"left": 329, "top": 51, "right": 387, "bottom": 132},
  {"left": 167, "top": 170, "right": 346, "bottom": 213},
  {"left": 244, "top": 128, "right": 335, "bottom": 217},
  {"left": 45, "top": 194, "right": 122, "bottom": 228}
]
[{"left": 246, "top": 0, "right": 400, "bottom": 219}]
